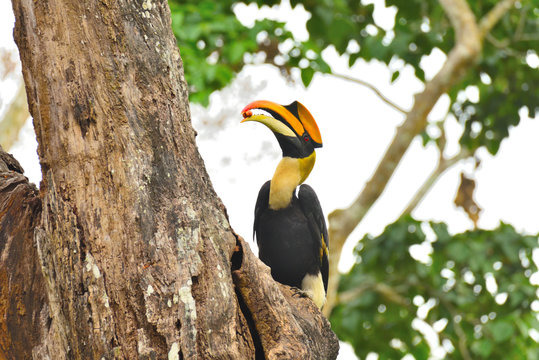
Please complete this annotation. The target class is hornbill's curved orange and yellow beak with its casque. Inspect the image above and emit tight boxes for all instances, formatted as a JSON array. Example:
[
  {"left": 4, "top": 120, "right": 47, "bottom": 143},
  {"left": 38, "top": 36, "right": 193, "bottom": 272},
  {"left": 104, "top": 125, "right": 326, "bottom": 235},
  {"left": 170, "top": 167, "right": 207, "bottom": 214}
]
[{"left": 241, "top": 100, "right": 322, "bottom": 147}]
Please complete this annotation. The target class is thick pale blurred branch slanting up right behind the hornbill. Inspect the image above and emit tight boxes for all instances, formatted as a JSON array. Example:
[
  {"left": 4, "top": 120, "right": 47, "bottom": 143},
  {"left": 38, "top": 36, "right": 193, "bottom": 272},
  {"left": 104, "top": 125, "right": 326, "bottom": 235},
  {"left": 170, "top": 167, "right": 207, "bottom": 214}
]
[{"left": 324, "top": 0, "right": 516, "bottom": 315}]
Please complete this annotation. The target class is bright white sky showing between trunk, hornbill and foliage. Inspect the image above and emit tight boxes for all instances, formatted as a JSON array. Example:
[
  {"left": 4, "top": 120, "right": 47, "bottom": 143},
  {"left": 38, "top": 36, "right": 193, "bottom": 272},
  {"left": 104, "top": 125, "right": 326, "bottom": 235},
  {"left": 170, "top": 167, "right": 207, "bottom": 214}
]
[{"left": 0, "top": 1, "right": 539, "bottom": 360}]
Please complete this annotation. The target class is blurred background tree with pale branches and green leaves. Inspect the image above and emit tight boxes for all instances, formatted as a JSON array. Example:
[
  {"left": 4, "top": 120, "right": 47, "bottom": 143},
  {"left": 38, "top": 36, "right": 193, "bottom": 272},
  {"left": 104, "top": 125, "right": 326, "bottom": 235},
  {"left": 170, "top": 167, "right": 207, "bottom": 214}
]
[{"left": 2, "top": 0, "right": 539, "bottom": 359}]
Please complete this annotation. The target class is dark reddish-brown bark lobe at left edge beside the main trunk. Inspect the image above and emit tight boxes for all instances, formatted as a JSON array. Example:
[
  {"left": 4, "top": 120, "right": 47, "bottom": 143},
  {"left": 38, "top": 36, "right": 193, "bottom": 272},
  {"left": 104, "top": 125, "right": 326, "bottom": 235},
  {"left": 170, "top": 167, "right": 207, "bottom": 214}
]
[{"left": 0, "top": 147, "right": 49, "bottom": 359}]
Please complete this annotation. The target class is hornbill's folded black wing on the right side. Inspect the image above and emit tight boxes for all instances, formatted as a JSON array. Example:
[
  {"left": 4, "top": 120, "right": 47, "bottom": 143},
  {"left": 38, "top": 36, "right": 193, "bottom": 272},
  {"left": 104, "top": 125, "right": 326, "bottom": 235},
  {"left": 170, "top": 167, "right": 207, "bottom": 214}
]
[{"left": 298, "top": 184, "right": 329, "bottom": 291}]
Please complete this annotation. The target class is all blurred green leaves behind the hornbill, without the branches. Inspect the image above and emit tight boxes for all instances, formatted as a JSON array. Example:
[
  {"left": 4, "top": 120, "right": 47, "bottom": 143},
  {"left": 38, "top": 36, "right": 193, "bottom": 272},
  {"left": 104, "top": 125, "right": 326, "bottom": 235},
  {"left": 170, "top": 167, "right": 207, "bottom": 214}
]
[{"left": 169, "top": 0, "right": 539, "bottom": 359}]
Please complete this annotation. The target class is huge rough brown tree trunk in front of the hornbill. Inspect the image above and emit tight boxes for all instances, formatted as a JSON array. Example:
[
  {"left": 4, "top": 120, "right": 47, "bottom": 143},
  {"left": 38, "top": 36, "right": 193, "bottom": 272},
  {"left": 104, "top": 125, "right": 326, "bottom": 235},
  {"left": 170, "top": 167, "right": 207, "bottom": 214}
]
[{"left": 0, "top": 0, "right": 338, "bottom": 359}]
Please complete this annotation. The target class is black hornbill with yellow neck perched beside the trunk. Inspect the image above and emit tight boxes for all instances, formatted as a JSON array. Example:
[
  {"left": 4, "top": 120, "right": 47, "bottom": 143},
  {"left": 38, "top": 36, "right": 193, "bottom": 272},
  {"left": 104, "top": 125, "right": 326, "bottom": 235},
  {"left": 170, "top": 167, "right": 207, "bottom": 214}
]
[{"left": 241, "top": 100, "right": 329, "bottom": 309}]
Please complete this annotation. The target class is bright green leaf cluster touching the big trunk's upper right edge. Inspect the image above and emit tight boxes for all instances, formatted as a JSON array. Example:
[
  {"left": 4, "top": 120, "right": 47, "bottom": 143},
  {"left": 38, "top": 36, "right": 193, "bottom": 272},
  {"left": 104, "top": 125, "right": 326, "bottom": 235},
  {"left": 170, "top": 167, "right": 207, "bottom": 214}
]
[{"left": 169, "top": 0, "right": 268, "bottom": 105}]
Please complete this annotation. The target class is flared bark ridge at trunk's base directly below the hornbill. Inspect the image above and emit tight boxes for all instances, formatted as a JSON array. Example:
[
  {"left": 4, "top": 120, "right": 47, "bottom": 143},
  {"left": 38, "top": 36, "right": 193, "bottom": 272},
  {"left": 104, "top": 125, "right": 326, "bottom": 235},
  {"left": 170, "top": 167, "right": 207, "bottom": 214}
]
[{"left": 233, "top": 239, "right": 339, "bottom": 360}]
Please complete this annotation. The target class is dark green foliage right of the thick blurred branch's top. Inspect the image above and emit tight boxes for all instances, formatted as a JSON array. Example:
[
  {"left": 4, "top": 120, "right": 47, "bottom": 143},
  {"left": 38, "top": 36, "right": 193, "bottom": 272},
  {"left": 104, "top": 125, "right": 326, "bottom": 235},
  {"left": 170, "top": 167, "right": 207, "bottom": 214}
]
[{"left": 450, "top": 2, "right": 539, "bottom": 154}]
